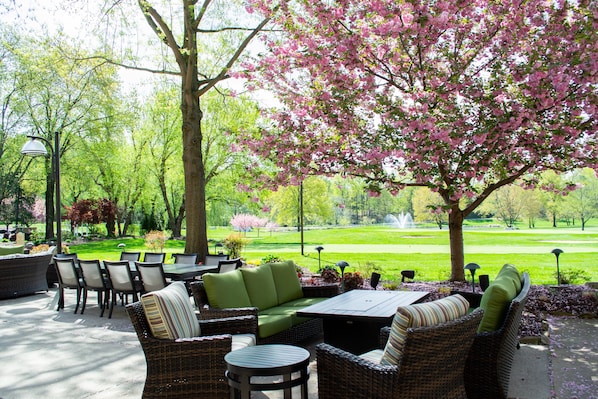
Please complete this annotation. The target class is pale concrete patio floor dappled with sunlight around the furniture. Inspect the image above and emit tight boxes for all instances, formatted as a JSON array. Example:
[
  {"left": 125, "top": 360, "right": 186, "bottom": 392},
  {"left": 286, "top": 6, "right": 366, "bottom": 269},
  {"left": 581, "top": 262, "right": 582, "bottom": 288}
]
[{"left": 0, "top": 289, "right": 598, "bottom": 399}]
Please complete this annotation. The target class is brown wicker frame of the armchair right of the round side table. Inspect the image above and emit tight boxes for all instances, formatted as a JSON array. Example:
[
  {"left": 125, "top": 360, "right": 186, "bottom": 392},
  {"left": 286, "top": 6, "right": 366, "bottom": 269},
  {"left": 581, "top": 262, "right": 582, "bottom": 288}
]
[{"left": 316, "top": 309, "right": 483, "bottom": 399}]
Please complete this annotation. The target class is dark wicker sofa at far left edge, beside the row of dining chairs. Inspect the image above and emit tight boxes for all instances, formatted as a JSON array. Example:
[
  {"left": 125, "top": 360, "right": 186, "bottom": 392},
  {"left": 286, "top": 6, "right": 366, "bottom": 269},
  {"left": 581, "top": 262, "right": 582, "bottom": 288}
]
[{"left": 0, "top": 252, "right": 52, "bottom": 299}]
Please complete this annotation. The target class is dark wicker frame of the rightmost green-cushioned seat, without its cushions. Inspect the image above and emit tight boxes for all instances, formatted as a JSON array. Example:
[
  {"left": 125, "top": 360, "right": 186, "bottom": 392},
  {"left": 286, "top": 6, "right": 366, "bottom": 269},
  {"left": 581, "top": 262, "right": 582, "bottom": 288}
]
[{"left": 465, "top": 273, "right": 530, "bottom": 399}]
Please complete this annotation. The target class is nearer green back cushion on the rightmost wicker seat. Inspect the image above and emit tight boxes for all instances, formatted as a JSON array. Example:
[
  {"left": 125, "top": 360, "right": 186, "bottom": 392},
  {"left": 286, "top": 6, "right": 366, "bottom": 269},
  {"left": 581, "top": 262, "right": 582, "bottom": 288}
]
[{"left": 478, "top": 275, "right": 517, "bottom": 332}]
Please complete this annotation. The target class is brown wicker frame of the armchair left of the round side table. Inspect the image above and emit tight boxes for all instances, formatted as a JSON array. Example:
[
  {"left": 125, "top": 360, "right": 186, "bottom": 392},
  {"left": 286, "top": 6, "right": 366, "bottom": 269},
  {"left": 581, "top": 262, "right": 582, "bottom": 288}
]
[{"left": 126, "top": 302, "right": 257, "bottom": 399}]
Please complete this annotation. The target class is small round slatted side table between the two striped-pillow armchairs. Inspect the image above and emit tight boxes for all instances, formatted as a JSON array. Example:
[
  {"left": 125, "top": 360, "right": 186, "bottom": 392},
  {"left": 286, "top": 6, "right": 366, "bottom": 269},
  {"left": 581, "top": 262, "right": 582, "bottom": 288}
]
[{"left": 224, "top": 344, "right": 309, "bottom": 399}]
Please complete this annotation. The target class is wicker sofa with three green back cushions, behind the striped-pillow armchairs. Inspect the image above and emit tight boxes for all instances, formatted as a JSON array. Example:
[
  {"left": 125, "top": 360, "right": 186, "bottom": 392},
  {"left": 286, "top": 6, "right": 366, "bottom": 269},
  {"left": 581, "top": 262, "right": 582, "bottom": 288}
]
[{"left": 191, "top": 261, "right": 338, "bottom": 344}]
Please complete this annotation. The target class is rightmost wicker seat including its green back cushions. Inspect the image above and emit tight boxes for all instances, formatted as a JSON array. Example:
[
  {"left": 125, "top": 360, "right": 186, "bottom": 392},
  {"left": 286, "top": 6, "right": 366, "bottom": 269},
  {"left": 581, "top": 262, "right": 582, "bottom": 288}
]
[{"left": 465, "top": 264, "right": 530, "bottom": 399}]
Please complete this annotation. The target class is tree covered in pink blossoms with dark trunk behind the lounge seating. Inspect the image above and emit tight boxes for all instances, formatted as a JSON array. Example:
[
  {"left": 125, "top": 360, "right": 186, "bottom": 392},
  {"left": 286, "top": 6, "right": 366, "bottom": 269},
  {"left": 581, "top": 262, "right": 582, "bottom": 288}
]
[{"left": 241, "top": 0, "right": 598, "bottom": 280}]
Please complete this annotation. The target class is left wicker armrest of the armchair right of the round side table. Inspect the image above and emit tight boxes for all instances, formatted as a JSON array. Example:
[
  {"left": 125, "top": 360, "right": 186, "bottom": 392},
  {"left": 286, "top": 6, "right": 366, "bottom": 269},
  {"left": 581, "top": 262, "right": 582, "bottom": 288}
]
[{"left": 316, "top": 344, "right": 398, "bottom": 398}]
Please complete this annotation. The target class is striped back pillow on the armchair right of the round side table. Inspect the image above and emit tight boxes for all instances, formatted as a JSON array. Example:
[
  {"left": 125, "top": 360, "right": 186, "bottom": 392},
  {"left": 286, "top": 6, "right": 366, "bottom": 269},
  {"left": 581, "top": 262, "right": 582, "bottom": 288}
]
[{"left": 380, "top": 294, "right": 469, "bottom": 365}]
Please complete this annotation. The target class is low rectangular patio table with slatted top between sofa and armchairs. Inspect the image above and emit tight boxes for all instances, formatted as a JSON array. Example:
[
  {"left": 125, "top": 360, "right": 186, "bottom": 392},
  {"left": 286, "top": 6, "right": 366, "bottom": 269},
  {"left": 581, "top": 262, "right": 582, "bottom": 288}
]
[{"left": 297, "top": 290, "right": 430, "bottom": 354}]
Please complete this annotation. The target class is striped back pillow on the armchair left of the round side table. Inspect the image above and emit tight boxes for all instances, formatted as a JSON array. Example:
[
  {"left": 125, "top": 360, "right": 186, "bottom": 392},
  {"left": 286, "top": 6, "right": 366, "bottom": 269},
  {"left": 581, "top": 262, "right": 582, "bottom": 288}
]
[{"left": 141, "top": 281, "right": 201, "bottom": 339}]
